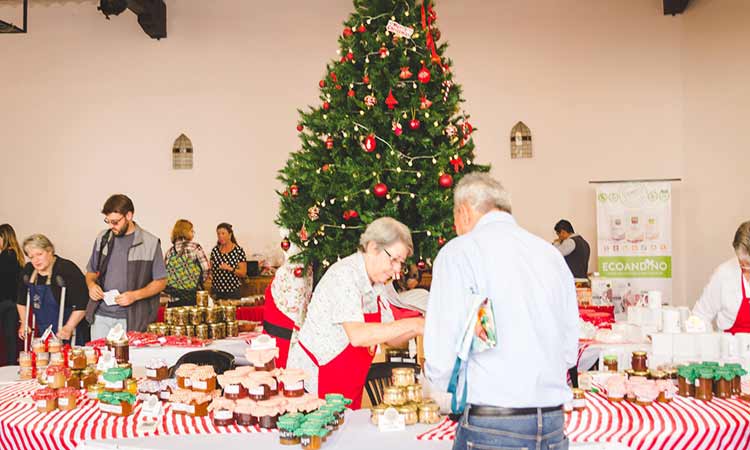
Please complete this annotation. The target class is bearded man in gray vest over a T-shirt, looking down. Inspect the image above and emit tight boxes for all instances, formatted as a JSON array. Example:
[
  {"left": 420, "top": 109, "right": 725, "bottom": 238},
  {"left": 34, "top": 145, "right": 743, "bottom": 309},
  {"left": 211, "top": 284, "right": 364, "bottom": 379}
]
[{"left": 86, "top": 194, "right": 167, "bottom": 339}]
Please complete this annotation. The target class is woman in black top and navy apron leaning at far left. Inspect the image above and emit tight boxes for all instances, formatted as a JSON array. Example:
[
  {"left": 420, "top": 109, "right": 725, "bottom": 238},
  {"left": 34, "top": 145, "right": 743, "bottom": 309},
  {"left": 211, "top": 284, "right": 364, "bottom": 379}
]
[{"left": 16, "top": 234, "right": 90, "bottom": 345}]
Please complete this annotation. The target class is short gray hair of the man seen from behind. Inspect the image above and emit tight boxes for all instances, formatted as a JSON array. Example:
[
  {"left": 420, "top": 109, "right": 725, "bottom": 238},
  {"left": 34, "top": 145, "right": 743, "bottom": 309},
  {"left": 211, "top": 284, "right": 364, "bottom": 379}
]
[{"left": 453, "top": 172, "right": 512, "bottom": 214}]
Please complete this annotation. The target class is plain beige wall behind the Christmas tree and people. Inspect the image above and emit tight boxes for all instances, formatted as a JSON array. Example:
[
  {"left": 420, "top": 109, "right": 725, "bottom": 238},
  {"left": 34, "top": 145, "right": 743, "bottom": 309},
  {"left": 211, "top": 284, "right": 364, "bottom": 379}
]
[{"left": 0, "top": 0, "right": 750, "bottom": 303}]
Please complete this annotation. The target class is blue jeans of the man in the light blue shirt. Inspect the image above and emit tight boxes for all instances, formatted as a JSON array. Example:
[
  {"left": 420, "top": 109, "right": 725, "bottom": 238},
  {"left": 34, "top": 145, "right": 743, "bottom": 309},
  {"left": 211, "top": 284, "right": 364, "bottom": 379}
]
[{"left": 453, "top": 405, "right": 568, "bottom": 450}]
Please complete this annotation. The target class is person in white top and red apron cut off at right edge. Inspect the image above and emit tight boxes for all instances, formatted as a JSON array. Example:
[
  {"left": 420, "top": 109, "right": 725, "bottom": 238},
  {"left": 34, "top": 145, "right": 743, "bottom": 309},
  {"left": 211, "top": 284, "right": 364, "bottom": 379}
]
[{"left": 693, "top": 221, "right": 750, "bottom": 334}]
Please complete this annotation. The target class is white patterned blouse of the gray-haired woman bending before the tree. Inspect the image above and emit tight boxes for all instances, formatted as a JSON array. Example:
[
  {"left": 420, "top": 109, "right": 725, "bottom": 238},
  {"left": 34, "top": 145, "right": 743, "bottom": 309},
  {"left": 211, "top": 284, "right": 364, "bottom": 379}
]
[{"left": 287, "top": 252, "right": 393, "bottom": 393}]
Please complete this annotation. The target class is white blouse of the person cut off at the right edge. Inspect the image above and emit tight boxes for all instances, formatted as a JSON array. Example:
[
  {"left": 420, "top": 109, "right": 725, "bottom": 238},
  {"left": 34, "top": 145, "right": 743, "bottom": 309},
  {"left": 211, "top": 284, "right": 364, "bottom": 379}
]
[{"left": 693, "top": 257, "right": 750, "bottom": 330}]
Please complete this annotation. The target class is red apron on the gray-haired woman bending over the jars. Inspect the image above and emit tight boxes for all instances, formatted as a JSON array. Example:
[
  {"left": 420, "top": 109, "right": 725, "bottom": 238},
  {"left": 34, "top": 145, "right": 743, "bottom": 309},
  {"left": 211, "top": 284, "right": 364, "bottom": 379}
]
[{"left": 299, "top": 297, "right": 382, "bottom": 409}]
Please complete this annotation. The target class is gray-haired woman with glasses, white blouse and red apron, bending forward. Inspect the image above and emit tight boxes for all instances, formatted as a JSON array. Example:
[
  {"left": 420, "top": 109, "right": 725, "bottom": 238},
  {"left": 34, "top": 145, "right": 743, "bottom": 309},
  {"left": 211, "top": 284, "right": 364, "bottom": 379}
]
[{"left": 287, "top": 217, "right": 424, "bottom": 409}]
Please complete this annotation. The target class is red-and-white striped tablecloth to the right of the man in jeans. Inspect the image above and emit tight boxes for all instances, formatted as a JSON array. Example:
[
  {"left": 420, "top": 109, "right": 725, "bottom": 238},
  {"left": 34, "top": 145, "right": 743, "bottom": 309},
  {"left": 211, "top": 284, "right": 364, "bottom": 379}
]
[{"left": 417, "top": 393, "right": 750, "bottom": 450}]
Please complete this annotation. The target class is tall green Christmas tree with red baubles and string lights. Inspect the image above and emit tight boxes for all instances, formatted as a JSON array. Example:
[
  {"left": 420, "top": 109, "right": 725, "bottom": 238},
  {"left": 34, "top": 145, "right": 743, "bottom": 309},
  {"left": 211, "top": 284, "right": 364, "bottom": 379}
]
[{"left": 276, "top": 0, "right": 489, "bottom": 278}]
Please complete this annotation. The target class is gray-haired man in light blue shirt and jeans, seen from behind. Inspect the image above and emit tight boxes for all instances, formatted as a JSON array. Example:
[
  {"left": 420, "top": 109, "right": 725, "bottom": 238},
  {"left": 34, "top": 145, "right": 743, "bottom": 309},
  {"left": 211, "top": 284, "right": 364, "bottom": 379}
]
[{"left": 424, "top": 174, "right": 578, "bottom": 449}]
